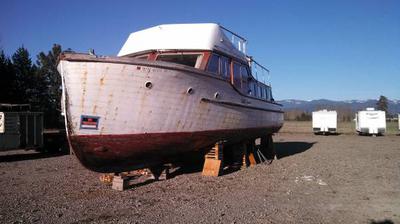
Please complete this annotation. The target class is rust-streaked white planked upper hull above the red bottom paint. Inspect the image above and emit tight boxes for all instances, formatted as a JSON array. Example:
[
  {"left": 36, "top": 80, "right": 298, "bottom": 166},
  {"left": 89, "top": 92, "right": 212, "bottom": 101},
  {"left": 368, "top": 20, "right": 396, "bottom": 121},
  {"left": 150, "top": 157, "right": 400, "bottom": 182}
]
[{"left": 60, "top": 56, "right": 283, "bottom": 135}]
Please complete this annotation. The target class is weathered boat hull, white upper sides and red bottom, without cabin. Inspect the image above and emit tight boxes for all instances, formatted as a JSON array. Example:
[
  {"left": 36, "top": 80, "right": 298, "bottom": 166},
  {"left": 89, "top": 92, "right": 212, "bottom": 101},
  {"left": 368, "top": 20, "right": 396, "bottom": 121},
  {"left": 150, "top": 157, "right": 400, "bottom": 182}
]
[{"left": 58, "top": 54, "right": 283, "bottom": 172}]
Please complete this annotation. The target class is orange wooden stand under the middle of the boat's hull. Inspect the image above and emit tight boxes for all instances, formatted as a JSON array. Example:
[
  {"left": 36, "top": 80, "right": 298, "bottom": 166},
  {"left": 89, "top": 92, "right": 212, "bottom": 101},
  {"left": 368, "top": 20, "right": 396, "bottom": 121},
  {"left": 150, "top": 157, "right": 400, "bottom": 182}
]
[{"left": 202, "top": 142, "right": 224, "bottom": 177}]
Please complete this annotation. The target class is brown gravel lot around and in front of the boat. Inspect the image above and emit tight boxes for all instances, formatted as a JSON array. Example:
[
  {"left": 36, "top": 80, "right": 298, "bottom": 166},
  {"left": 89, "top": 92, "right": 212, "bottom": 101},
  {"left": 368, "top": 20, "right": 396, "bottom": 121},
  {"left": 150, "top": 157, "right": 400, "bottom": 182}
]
[{"left": 0, "top": 133, "right": 400, "bottom": 223}]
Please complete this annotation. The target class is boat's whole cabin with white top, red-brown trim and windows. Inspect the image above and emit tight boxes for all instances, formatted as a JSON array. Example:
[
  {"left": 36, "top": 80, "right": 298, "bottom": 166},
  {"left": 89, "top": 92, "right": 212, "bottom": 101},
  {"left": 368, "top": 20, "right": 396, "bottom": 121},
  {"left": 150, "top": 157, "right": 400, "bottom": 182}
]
[{"left": 118, "top": 23, "right": 274, "bottom": 102}]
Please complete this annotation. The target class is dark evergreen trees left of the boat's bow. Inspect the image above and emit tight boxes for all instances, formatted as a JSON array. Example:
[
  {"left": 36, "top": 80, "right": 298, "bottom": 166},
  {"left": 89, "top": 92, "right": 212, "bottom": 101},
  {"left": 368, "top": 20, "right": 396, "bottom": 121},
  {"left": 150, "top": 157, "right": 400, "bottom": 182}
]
[{"left": 0, "top": 44, "right": 63, "bottom": 128}]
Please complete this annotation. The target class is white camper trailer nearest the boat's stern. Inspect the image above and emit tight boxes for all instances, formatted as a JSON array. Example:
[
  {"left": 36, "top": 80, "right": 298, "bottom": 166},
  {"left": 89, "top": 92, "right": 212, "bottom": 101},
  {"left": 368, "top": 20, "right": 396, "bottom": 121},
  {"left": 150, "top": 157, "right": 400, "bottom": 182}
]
[{"left": 312, "top": 110, "right": 337, "bottom": 134}]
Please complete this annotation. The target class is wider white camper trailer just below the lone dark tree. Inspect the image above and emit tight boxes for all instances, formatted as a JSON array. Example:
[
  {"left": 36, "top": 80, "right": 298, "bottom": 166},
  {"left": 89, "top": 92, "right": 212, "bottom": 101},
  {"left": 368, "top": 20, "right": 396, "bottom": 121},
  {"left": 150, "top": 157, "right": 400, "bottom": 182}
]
[{"left": 355, "top": 108, "right": 386, "bottom": 135}]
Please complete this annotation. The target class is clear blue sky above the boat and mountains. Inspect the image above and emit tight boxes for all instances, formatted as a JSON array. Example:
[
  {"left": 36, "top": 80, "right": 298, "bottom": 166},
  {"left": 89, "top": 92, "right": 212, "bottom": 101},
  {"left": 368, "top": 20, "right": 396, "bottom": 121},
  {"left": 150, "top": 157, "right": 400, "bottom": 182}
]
[{"left": 0, "top": 0, "right": 400, "bottom": 100}]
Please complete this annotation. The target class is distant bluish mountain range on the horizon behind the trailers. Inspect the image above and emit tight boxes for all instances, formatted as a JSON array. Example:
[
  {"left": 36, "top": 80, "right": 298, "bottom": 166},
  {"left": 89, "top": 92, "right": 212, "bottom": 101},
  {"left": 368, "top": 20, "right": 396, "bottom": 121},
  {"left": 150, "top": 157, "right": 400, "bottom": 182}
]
[{"left": 277, "top": 99, "right": 400, "bottom": 114}]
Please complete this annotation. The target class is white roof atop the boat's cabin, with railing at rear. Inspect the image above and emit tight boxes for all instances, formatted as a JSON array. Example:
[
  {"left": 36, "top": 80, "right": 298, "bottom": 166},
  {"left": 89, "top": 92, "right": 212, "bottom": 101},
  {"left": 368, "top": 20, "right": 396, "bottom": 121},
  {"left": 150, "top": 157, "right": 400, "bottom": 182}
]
[{"left": 118, "top": 23, "right": 247, "bottom": 60}]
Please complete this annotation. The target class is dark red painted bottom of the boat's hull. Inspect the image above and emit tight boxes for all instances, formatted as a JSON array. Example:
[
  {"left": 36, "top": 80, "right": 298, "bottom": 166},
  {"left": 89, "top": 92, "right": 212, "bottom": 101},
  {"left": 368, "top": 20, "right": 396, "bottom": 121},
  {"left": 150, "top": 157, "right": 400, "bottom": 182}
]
[{"left": 69, "top": 127, "right": 280, "bottom": 173}]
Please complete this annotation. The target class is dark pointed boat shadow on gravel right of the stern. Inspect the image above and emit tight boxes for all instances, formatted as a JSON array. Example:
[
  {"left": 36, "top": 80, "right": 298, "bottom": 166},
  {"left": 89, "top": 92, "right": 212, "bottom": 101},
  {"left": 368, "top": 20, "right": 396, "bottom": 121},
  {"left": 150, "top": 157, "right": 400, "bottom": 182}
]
[{"left": 274, "top": 142, "right": 317, "bottom": 159}]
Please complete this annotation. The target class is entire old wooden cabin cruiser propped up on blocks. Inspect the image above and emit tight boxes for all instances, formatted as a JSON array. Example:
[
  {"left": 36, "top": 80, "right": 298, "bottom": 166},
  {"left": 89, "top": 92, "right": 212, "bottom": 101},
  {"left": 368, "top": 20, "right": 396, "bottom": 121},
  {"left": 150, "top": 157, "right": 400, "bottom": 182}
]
[{"left": 57, "top": 23, "right": 283, "bottom": 173}]
